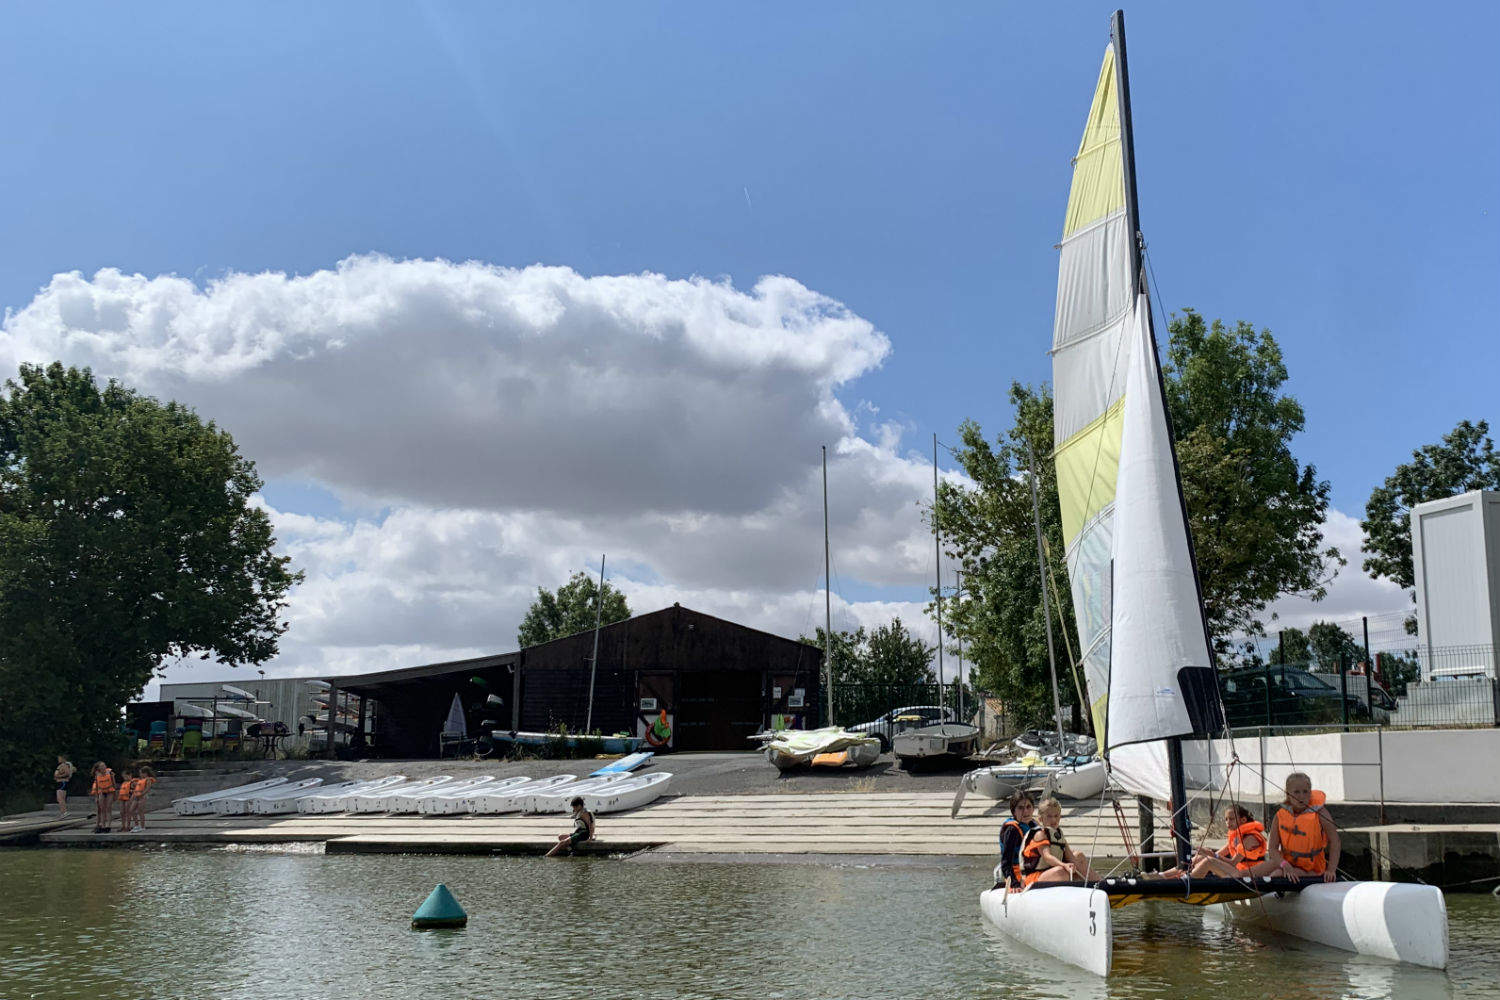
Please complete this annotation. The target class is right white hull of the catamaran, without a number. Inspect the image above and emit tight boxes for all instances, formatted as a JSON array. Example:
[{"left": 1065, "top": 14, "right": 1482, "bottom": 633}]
[{"left": 1221, "top": 882, "right": 1448, "bottom": 969}]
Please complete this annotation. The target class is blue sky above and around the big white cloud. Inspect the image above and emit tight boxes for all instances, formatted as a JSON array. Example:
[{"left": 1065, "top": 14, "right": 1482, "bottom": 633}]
[{"left": 0, "top": 3, "right": 1500, "bottom": 683}]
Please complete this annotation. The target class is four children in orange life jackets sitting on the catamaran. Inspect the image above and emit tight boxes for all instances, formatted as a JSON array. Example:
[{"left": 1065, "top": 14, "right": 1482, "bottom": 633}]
[{"left": 995, "top": 772, "right": 1341, "bottom": 892}]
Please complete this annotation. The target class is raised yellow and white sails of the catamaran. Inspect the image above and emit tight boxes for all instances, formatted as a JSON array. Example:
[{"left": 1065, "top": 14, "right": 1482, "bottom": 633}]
[{"left": 1053, "top": 45, "right": 1223, "bottom": 799}]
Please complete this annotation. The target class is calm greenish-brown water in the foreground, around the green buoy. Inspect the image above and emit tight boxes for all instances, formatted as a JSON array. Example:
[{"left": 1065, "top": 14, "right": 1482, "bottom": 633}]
[{"left": 0, "top": 849, "right": 1500, "bottom": 1000}]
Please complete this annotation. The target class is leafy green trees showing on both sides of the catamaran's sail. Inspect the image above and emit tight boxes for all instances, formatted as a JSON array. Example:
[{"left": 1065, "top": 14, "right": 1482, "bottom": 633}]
[{"left": 935, "top": 310, "right": 1343, "bottom": 721}]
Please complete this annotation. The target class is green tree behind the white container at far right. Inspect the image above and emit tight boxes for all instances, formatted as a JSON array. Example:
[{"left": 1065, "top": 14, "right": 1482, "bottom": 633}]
[{"left": 1359, "top": 420, "right": 1500, "bottom": 599}]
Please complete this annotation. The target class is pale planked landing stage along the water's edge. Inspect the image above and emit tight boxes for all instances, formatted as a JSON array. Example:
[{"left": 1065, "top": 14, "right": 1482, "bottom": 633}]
[{"left": 42, "top": 792, "right": 1137, "bottom": 858}]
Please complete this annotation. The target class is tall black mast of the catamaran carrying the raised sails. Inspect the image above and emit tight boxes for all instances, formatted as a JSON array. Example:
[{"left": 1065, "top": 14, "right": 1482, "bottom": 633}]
[{"left": 1110, "top": 10, "right": 1223, "bottom": 865}]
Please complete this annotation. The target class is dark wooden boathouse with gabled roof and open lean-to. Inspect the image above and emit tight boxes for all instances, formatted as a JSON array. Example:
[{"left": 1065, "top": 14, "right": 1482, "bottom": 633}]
[{"left": 324, "top": 604, "right": 822, "bottom": 757}]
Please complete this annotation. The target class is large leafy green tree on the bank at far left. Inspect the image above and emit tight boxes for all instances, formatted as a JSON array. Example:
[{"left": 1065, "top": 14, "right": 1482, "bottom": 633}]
[{"left": 0, "top": 364, "right": 302, "bottom": 796}]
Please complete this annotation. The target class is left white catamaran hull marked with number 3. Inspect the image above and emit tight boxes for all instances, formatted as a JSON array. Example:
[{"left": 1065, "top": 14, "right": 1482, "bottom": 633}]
[{"left": 980, "top": 886, "right": 1115, "bottom": 976}]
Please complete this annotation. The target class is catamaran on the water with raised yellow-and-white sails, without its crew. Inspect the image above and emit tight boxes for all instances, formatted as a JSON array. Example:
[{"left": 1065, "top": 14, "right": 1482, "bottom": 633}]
[{"left": 980, "top": 10, "right": 1448, "bottom": 975}]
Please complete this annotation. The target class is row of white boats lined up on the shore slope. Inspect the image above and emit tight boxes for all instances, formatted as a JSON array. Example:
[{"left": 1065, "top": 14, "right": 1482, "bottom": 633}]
[{"left": 173, "top": 771, "right": 672, "bottom": 816}]
